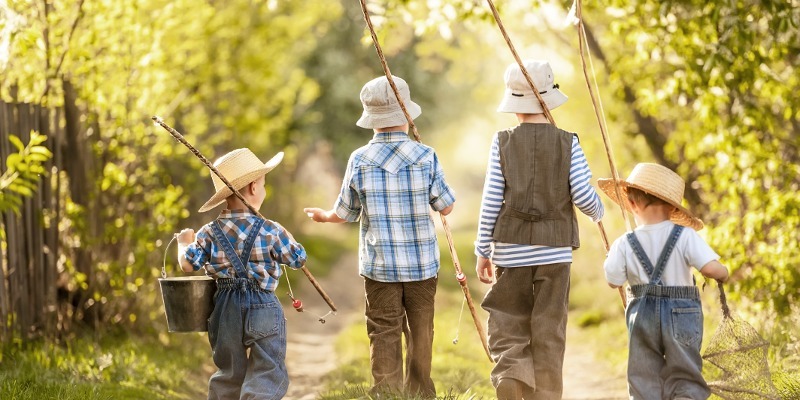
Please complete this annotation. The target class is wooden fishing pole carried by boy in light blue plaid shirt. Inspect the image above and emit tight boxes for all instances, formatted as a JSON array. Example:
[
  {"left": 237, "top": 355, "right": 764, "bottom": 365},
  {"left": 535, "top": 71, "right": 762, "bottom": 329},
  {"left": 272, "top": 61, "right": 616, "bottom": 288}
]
[{"left": 360, "top": 0, "right": 494, "bottom": 362}]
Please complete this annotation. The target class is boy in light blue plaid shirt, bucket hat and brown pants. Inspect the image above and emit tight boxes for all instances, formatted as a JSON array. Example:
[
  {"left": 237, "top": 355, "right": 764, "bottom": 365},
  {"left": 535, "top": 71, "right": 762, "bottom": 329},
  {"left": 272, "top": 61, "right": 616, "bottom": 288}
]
[{"left": 304, "top": 77, "right": 455, "bottom": 398}]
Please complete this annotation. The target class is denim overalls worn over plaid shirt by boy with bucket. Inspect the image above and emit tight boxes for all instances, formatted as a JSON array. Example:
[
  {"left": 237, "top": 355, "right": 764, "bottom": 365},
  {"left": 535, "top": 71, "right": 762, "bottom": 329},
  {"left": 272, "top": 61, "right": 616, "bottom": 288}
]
[{"left": 208, "top": 219, "right": 289, "bottom": 400}]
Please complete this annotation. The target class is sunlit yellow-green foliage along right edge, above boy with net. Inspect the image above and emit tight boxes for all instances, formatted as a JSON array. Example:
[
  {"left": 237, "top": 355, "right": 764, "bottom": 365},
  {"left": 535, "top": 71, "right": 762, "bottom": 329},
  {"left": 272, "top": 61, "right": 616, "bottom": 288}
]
[{"left": 588, "top": 1, "right": 800, "bottom": 316}]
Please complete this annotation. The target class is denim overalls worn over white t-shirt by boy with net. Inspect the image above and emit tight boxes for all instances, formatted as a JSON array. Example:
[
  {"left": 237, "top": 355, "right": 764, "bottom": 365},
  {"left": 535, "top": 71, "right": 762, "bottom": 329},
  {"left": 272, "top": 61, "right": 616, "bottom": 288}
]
[{"left": 625, "top": 225, "right": 710, "bottom": 400}]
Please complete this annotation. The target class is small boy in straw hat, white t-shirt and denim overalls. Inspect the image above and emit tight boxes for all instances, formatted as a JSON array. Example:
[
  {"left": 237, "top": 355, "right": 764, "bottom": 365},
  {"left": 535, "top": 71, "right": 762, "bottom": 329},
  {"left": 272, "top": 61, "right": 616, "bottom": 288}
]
[{"left": 598, "top": 164, "right": 728, "bottom": 400}]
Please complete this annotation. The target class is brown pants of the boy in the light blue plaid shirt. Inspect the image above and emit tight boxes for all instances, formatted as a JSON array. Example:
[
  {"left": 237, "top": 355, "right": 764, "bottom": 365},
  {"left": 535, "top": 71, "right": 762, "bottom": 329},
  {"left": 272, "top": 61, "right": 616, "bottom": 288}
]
[{"left": 364, "top": 278, "right": 438, "bottom": 398}]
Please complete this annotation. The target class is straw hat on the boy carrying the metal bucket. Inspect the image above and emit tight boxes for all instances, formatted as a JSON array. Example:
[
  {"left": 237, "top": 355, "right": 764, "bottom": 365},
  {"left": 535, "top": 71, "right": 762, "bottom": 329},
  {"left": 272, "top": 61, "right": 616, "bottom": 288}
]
[{"left": 198, "top": 149, "right": 283, "bottom": 212}]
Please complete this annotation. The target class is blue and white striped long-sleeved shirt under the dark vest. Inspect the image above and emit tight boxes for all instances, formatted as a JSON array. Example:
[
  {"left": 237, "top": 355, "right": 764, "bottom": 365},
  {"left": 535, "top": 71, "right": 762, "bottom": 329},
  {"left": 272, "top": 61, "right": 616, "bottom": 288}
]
[{"left": 475, "top": 133, "right": 604, "bottom": 267}]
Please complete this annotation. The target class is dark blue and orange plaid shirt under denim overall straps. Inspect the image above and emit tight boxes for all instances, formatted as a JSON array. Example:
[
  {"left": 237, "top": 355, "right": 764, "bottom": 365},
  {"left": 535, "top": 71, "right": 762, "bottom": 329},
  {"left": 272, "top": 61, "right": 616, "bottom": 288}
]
[{"left": 185, "top": 210, "right": 306, "bottom": 291}]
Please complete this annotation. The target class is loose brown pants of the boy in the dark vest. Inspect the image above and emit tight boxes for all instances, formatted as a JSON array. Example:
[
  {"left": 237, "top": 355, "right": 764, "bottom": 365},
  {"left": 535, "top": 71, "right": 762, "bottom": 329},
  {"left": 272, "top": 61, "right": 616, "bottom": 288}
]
[{"left": 481, "top": 263, "right": 571, "bottom": 400}]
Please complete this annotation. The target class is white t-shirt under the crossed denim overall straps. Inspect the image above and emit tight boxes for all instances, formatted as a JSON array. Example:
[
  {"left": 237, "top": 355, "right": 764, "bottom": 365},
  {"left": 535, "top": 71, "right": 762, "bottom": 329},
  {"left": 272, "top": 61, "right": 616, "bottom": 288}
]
[{"left": 603, "top": 221, "right": 719, "bottom": 286}]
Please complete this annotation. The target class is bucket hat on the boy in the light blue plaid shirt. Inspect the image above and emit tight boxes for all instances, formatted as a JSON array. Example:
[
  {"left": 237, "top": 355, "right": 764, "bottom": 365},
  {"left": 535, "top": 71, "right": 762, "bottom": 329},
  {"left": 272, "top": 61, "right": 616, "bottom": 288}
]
[{"left": 356, "top": 75, "right": 422, "bottom": 129}]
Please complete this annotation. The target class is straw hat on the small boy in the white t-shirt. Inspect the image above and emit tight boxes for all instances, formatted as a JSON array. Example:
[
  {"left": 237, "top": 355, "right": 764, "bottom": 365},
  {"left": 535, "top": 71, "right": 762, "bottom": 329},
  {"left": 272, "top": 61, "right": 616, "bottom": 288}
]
[{"left": 597, "top": 163, "right": 703, "bottom": 231}]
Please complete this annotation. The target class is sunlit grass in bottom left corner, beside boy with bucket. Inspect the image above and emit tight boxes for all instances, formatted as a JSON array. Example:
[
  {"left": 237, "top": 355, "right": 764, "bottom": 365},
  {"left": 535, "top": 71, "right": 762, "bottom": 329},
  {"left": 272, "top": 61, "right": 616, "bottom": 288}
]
[{"left": 0, "top": 328, "right": 210, "bottom": 400}]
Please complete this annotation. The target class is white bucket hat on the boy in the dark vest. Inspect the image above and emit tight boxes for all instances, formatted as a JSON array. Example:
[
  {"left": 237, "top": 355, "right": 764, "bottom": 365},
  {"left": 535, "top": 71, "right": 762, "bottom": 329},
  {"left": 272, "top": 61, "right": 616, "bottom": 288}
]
[{"left": 497, "top": 60, "right": 567, "bottom": 114}]
